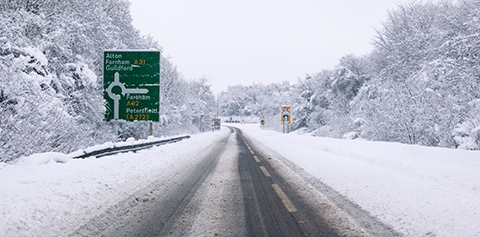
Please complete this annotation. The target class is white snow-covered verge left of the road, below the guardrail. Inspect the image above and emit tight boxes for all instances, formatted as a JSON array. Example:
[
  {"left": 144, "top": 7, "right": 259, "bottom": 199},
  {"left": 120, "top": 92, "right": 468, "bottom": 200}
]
[{"left": 0, "top": 129, "right": 229, "bottom": 236}]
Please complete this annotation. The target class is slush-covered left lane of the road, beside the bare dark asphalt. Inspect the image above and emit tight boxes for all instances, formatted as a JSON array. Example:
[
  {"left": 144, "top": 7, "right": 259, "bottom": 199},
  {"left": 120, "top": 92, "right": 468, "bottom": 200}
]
[{"left": 71, "top": 127, "right": 245, "bottom": 236}]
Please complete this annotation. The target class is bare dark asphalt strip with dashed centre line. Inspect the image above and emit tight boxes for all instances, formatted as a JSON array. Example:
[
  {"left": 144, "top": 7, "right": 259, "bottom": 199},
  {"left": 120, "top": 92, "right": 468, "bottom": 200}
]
[{"left": 237, "top": 129, "right": 337, "bottom": 236}]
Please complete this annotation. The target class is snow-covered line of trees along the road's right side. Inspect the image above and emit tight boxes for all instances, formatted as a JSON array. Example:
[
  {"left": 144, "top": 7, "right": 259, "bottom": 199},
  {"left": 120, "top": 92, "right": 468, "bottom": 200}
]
[{"left": 220, "top": 0, "right": 480, "bottom": 150}]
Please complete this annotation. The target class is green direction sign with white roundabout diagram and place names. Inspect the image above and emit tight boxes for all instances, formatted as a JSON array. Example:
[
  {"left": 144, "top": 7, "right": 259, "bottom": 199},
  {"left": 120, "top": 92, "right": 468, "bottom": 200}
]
[{"left": 103, "top": 51, "right": 160, "bottom": 122}]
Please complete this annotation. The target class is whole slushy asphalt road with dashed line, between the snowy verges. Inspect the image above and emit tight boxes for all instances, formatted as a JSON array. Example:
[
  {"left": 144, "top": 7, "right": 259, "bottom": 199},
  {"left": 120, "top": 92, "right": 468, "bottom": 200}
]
[{"left": 71, "top": 128, "right": 398, "bottom": 236}]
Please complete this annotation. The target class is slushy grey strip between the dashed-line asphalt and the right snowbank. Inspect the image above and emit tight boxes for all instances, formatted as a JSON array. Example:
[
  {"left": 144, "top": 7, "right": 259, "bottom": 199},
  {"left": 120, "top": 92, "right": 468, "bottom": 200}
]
[{"left": 243, "top": 130, "right": 401, "bottom": 236}]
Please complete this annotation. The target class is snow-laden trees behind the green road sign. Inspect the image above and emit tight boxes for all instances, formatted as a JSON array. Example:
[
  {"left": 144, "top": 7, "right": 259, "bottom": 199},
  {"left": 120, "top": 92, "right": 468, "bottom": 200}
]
[{"left": 0, "top": 0, "right": 211, "bottom": 161}]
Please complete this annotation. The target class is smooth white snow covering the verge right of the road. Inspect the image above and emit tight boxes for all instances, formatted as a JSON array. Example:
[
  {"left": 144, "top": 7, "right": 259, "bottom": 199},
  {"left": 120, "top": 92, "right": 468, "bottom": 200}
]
[{"left": 236, "top": 125, "right": 480, "bottom": 236}]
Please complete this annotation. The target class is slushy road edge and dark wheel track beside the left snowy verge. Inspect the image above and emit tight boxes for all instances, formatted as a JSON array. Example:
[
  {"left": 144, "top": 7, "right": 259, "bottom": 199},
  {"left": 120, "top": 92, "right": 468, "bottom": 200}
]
[{"left": 70, "top": 131, "right": 232, "bottom": 236}]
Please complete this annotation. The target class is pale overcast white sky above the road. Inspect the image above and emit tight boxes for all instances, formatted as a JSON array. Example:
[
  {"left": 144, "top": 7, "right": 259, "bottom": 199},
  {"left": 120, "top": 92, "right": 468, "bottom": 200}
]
[{"left": 130, "top": 0, "right": 410, "bottom": 93}]
